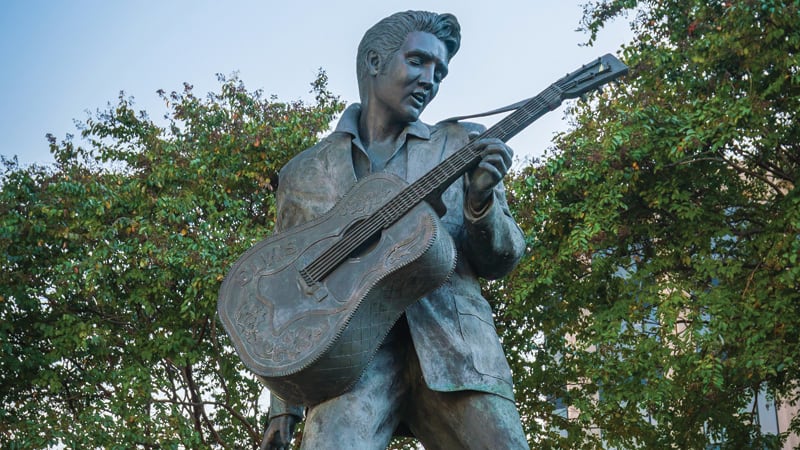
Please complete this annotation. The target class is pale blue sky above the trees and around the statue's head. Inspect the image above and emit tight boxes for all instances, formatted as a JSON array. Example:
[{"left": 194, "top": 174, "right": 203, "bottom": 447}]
[{"left": 0, "top": 0, "right": 631, "bottom": 168}]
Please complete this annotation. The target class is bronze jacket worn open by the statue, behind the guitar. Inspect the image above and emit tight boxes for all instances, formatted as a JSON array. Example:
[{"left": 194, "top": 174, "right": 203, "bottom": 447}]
[{"left": 270, "top": 105, "right": 525, "bottom": 416}]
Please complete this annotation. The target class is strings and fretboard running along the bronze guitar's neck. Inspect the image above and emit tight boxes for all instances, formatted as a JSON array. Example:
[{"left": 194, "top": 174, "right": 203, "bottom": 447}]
[{"left": 301, "top": 85, "right": 561, "bottom": 283}]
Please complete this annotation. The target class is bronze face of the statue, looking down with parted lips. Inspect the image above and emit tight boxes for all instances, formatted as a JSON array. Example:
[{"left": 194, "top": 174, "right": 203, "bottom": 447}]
[{"left": 370, "top": 31, "right": 447, "bottom": 124}]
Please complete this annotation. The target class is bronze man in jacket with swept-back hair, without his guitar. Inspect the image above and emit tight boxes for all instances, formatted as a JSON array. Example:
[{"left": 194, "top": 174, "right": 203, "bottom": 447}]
[{"left": 263, "top": 11, "right": 528, "bottom": 450}]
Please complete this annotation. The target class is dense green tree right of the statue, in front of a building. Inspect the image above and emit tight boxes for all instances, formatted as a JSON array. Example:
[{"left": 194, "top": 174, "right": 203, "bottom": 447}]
[{"left": 496, "top": 0, "right": 800, "bottom": 449}]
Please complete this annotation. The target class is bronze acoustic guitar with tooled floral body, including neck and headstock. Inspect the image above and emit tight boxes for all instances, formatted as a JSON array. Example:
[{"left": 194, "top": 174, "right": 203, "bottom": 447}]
[{"left": 217, "top": 54, "right": 628, "bottom": 406}]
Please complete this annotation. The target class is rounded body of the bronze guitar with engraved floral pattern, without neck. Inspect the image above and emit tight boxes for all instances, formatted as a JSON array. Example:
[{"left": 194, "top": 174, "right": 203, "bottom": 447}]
[{"left": 218, "top": 173, "right": 456, "bottom": 405}]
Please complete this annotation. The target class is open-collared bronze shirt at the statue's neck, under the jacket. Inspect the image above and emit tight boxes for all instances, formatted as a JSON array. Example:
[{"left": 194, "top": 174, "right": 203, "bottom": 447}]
[{"left": 336, "top": 103, "right": 431, "bottom": 179}]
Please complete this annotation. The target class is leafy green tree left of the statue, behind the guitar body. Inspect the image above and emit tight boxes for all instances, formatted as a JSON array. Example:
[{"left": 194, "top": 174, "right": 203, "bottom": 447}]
[{"left": 0, "top": 72, "right": 342, "bottom": 448}]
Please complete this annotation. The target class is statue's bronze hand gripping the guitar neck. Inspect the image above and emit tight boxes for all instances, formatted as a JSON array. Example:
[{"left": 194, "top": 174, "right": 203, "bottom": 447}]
[{"left": 467, "top": 138, "right": 514, "bottom": 211}]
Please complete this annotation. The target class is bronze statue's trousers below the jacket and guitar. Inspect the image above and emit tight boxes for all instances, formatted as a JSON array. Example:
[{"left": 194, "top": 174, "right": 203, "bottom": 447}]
[{"left": 300, "top": 320, "right": 529, "bottom": 450}]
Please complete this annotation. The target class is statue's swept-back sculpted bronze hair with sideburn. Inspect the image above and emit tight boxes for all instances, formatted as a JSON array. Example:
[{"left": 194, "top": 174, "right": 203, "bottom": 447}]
[{"left": 356, "top": 11, "right": 461, "bottom": 85}]
